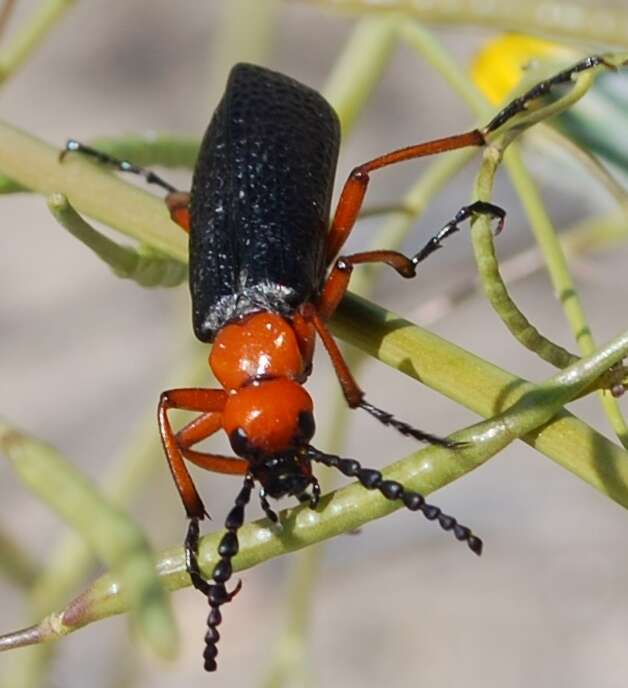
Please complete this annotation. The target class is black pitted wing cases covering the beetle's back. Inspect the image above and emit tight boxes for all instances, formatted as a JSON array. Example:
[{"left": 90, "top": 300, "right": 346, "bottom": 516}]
[{"left": 190, "top": 64, "right": 340, "bottom": 341}]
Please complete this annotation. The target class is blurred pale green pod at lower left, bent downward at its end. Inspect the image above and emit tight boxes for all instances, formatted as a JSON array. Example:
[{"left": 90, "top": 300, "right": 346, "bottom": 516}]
[{"left": 0, "top": 421, "right": 177, "bottom": 657}]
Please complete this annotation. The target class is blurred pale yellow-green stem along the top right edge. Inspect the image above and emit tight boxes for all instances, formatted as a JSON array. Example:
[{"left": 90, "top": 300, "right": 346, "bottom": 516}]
[{"left": 310, "top": 0, "right": 628, "bottom": 47}]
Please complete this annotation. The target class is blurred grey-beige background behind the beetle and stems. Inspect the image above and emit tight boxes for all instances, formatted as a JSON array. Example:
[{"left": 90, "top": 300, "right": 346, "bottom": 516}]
[{"left": 0, "top": 0, "right": 628, "bottom": 688}]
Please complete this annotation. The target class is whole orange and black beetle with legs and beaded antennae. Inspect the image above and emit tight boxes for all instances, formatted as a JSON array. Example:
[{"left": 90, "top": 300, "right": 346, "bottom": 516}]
[{"left": 62, "top": 57, "right": 602, "bottom": 671}]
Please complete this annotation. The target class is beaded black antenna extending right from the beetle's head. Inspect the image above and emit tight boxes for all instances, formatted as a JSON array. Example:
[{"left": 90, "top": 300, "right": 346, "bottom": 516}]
[{"left": 308, "top": 447, "right": 482, "bottom": 555}]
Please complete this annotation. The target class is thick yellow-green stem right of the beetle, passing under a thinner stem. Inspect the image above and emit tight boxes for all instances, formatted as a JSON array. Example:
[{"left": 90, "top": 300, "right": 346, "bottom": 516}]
[{"left": 333, "top": 296, "right": 628, "bottom": 500}]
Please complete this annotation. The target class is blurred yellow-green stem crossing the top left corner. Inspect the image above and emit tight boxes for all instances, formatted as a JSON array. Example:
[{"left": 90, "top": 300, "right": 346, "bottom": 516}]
[{"left": 0, "top": 0, "right": 76, "bottom": 83}]
